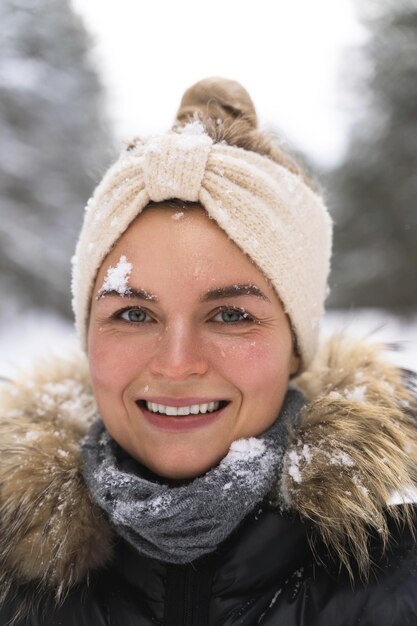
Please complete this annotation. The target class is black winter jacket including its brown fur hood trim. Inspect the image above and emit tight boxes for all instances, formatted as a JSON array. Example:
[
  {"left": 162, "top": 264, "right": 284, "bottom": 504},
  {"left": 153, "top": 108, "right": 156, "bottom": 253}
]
[{"left": 0, "top": 340, "right": 417, "bottom": 626}]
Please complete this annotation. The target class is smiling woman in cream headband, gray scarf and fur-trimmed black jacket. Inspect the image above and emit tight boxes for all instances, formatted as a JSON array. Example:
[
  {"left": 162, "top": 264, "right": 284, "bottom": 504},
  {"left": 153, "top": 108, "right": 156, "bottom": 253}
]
[{"left": 0, "top": 79, "right": 417, "bottom": 626}]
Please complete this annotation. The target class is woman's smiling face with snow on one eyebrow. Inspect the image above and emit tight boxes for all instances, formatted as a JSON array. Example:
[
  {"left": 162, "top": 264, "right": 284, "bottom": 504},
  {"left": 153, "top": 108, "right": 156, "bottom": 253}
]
[{"left": 88, "top": 206, "right": 298, "bottom": 479}]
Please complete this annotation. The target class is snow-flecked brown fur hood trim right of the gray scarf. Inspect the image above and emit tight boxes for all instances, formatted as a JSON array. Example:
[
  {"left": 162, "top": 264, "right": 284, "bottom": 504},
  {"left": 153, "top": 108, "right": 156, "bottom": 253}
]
[{"left": 280, "top": 335, "right": 417, "bottom": 578}]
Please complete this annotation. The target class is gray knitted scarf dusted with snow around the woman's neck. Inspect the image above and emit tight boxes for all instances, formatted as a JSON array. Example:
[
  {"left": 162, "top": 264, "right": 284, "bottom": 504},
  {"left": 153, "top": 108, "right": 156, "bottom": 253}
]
[{"left": 83, "top": 390, "right": 304, "bottom": 564}]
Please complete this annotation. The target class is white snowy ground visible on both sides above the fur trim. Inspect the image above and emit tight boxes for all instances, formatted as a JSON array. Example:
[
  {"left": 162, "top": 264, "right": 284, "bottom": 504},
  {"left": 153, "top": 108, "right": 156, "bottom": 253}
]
[{"left": 0, "top": 308, "right": 417, "bottom": 377}]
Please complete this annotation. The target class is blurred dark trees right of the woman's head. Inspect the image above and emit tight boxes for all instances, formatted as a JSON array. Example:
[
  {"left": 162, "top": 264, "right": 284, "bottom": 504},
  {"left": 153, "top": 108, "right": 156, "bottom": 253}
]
[{"left": 325, "top": 0, "right": 417, "bottom": 313}]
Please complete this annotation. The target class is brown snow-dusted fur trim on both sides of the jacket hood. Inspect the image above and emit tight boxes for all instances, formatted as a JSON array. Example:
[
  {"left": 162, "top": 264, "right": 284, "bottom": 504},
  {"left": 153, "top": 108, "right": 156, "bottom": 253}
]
[{"left": 0, "top": 336, "right": 417, "bottom": 598}]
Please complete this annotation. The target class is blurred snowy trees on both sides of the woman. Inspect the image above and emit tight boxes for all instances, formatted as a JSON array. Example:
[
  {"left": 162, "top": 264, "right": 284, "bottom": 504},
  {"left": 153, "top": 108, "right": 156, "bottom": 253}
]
[{"left": 0, "top": 0, "right": 417, "bottom": 315}]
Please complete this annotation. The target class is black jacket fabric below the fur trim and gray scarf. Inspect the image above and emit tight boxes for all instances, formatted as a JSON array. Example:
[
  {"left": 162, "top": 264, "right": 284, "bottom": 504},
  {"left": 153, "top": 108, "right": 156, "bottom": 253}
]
[{"left": 0, "top": 509, "right": 417, "bottom": 626}]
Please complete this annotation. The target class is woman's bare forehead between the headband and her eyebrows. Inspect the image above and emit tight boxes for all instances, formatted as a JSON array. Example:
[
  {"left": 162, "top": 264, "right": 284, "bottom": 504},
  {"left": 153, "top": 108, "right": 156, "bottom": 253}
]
[{"left": 95, "top": 205, "right": 277, "bottom": 300}]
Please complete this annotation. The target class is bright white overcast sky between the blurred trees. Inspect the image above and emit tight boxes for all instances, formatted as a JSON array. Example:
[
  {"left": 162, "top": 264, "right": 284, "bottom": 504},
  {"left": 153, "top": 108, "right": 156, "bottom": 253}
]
[{"left": 72, "top": 0, "right": 366, "bottom": 165}]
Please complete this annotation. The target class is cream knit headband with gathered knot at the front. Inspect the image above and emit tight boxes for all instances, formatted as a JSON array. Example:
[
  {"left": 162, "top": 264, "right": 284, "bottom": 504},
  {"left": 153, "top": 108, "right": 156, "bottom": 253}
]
[{"left": 72, "top": 122, "right": 332, "bottom": 369}]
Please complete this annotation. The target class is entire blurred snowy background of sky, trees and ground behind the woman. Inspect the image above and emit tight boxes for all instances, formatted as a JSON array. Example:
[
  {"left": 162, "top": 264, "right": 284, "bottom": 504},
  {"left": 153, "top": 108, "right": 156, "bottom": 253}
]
[{"left": 0, "top": 0, "right": 417, "bottom": 376}]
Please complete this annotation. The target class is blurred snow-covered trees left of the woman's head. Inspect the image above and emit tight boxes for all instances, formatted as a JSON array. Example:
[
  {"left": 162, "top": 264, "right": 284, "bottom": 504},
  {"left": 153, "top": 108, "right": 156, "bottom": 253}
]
[{"left": 0, "top": 0, "right": 114, "bottom": 315}]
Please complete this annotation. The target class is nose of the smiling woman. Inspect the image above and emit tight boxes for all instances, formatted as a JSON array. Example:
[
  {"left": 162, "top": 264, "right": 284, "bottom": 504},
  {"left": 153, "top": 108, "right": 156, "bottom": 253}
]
[{"left": 149, "top": 322, "right": 208, "bottom": 381}]
